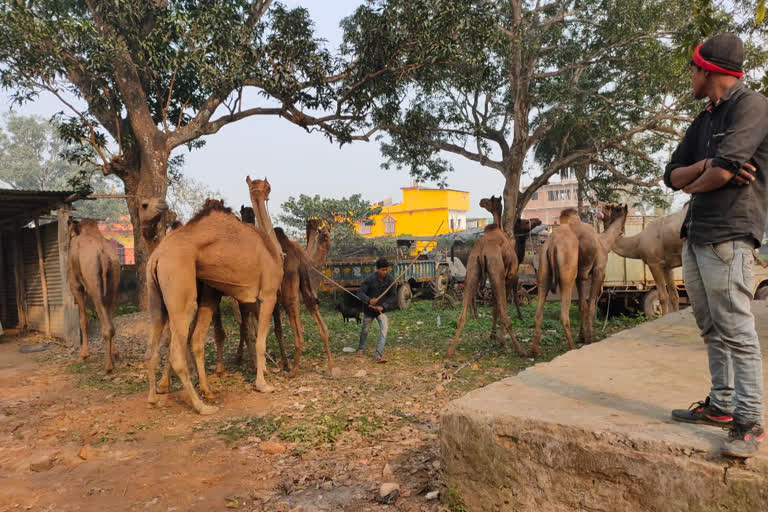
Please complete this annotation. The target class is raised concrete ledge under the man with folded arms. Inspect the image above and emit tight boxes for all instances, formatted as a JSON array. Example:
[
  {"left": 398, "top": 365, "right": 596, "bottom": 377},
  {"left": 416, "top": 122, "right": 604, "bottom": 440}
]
[{"left": 441, "top": 302, "right": 768, "bottom": 512}]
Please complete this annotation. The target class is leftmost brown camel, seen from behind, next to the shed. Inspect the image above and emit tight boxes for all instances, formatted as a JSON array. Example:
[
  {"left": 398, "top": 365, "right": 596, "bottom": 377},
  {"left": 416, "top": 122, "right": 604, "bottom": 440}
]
[{"left": 67, "top": 219, "right": 120, "bottom": 373}]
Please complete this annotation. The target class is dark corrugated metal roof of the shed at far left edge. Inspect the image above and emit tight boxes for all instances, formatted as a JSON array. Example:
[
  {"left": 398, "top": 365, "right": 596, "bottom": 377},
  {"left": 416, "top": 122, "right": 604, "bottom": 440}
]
[{"left": 0, "top": 188, "right": 80, "bottom": 229}]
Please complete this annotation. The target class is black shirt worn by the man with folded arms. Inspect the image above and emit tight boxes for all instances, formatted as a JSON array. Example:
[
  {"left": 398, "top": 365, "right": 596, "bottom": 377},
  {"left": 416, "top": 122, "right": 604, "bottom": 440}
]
[{"left": 664, "top": 82, "right": 768, "bottom": 247}]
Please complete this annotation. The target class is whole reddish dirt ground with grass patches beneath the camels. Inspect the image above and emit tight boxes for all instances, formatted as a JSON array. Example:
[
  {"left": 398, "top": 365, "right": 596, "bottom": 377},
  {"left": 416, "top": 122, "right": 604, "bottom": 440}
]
[{"left": 0, "top": 302, "right": 642, "bottom": 512}]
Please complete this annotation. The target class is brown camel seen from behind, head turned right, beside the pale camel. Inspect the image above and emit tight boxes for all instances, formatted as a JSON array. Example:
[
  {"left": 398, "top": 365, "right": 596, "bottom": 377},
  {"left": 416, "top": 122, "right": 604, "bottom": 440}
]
[{"left": 531, "top": 204, "right": 627, "bottom": 357}]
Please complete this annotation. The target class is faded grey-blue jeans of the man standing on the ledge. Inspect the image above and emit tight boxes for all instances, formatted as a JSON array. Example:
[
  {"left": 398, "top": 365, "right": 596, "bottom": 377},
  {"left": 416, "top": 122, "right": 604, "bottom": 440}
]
[{"left": 683, "top": 238, "right": 763, "bottom": 423}]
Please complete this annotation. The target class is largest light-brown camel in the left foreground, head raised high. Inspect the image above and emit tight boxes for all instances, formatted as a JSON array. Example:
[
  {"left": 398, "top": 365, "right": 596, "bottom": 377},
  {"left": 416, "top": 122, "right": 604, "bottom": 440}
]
[{"left": 147, "top": 177, "right": 283, "bottom": 414}]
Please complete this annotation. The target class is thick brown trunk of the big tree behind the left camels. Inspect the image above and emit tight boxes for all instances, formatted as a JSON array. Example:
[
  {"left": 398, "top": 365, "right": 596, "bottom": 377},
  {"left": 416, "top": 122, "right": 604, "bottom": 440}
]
[{"left": 123, "top": 149, "right": 170, "bottom": 311}]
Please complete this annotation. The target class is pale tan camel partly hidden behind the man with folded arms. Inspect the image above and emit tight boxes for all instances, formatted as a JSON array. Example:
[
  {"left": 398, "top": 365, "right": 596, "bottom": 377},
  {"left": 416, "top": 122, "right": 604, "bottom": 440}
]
[{"left": 613, "top": 203, "right": 688, "bottom": 315}]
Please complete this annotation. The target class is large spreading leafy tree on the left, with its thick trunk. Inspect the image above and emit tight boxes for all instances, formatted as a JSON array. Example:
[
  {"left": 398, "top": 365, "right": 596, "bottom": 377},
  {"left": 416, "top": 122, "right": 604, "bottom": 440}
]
[{"left": 0, "top": 0, "right": 423, "bottom": 307}]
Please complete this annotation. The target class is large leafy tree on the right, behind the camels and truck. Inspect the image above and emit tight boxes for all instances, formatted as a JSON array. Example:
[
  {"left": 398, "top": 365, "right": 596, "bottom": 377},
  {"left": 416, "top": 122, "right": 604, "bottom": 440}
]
[{"left": 345, "top": 0, "right": 736, "bottom": 231}]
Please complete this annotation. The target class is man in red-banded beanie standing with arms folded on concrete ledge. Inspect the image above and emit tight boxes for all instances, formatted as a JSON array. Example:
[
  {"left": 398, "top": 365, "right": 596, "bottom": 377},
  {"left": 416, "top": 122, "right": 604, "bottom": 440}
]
[{"left": 664, "top": 33, "right": 768, "bottom": 457}]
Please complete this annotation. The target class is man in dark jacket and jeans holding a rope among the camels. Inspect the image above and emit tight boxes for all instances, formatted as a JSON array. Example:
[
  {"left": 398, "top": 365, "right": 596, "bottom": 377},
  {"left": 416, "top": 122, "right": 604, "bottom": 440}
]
[{"left": 357, "top": 258, "right": 395, "bottom": 363}]
